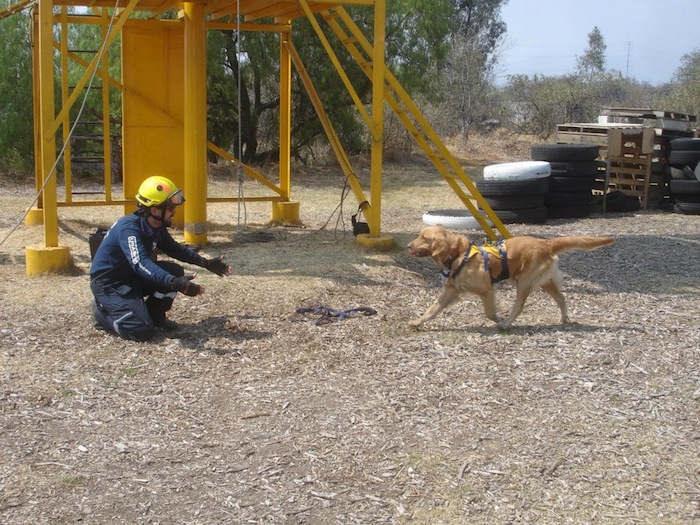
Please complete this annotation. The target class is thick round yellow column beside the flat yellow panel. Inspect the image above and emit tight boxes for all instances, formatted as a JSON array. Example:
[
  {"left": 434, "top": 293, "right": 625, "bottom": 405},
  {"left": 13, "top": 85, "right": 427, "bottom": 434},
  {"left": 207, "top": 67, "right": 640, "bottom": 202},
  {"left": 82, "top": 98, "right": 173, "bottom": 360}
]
[{"left": 184, "top": 2, "right": 207, "bottom": 246}]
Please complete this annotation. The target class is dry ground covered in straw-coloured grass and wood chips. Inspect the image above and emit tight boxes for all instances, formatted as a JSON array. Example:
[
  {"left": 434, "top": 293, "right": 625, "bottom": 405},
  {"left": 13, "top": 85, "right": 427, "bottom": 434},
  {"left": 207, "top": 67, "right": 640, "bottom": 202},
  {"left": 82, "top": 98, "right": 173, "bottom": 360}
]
[{"left": 0, "top": 140, "right": 700, "bottom": 525}]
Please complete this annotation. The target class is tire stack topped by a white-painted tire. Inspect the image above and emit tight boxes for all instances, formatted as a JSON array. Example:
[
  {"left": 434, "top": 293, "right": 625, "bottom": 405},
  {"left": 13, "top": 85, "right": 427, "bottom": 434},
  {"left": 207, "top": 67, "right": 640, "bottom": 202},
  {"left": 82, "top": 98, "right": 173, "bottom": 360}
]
[{"left": 476, "top": 161, "right": 551, "bottom": 224}]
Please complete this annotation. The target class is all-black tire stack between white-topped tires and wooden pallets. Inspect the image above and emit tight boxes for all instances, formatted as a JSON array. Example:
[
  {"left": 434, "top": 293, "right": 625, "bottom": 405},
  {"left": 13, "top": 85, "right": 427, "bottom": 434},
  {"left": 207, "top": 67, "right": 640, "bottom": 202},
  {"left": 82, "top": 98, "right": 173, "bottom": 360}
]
[{"left": 530, "top": 144, "right": 601, "bottom": 219}]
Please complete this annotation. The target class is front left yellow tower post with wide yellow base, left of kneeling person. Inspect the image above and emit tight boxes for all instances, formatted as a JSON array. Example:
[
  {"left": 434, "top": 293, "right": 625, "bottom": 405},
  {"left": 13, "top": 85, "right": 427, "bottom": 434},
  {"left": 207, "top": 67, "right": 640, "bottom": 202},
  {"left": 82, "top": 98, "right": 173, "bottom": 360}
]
[{"left": 25, "top": 0, "right": 72, "bottom": 275}]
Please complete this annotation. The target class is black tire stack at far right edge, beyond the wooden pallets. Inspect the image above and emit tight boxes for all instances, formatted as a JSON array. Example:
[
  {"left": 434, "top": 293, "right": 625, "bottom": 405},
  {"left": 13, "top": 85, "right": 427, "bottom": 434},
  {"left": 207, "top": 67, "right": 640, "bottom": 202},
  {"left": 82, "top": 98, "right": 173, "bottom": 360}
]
[{"left": 668, "top": 137, "right": 700, "bottom": 215}]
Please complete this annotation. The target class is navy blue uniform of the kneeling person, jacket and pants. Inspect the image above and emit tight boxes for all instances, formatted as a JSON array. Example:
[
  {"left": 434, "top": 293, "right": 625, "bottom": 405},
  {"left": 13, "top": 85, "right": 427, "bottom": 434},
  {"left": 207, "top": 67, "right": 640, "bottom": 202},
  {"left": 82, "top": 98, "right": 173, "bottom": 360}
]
[{"left": 90, "top": 210, "right": 207, "bottom": 341}]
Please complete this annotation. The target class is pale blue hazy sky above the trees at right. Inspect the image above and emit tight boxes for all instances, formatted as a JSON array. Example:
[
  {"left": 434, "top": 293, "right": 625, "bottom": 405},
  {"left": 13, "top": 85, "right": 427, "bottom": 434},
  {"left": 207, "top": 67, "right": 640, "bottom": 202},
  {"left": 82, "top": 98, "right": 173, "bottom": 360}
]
[{"left": 496, "top": 0, "right": 700, "bottom": 85}]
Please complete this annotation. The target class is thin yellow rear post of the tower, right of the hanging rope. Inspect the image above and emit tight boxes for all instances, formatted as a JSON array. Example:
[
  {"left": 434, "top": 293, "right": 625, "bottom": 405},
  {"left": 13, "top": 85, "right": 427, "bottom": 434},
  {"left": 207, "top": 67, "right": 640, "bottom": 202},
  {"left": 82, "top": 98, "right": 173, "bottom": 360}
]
[{"left": 272, "top": 22, "right": 299, "bottom": 224}]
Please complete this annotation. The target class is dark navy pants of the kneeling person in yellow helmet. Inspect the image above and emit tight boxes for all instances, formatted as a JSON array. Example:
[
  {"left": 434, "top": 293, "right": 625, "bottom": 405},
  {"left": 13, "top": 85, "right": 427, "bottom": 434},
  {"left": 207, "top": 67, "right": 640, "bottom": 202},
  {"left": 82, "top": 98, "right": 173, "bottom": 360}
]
[{"left": 90, "top": 261, "right": 185, "bottom": 341}]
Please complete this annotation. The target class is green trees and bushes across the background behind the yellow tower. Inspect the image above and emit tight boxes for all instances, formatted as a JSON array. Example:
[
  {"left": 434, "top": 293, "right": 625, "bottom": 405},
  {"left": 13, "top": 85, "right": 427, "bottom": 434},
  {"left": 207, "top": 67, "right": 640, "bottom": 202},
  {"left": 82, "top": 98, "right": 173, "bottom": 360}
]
[{"left": 0, "top": 0, "right": 700, "bottom": 173}]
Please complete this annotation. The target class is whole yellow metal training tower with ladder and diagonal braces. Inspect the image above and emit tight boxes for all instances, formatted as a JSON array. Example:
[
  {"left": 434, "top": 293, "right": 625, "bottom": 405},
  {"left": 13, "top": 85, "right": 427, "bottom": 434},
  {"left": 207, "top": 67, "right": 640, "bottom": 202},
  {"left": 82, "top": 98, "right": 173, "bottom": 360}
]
[{"left": 0, "top": 0, "right": 509, "bottom": 275}]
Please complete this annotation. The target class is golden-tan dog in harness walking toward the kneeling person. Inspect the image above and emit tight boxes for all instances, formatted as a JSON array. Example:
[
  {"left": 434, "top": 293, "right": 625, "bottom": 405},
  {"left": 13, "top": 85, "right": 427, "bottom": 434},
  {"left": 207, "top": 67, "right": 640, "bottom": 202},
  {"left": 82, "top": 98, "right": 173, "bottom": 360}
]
[{"left": 408, "top": 225, "right": 615, "bottom": 330}]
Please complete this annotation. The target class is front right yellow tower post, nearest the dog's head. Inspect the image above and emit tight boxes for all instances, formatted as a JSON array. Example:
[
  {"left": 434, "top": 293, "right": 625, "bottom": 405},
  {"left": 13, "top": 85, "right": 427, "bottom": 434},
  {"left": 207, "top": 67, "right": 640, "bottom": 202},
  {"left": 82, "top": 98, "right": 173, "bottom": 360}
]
[{"left": 357, "top": 0, "right": 394, "bottom": 249}]
